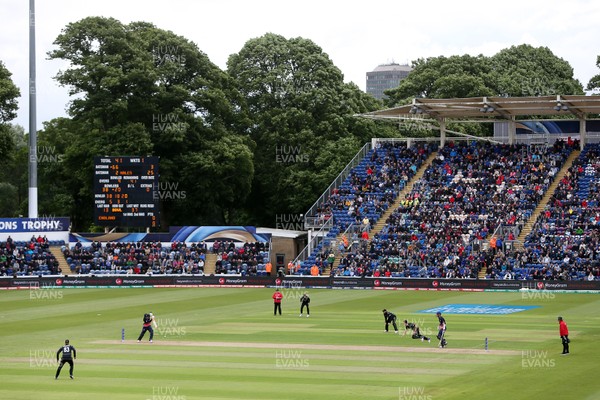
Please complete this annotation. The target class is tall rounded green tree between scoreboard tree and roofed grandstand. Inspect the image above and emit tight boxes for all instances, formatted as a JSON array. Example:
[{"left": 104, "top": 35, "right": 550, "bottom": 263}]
[{"left": 227, "top": 33, "right": 379, "bottom": 226}]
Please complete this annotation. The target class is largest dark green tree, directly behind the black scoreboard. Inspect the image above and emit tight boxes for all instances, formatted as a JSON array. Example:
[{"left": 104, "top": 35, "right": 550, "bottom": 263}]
[{"left": 49, "top": 17, "right": 253, "bottom": 227}]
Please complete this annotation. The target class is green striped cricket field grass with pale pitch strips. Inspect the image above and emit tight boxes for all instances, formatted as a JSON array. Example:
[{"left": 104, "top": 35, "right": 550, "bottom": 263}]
[{"left": 0, "top": 288, "right": 600, "bottom": 400}]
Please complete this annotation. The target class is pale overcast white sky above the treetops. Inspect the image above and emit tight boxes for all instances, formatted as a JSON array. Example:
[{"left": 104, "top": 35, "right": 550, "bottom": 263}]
[{"left": 0, "top": 0, "right": 600, "bottom": 131}]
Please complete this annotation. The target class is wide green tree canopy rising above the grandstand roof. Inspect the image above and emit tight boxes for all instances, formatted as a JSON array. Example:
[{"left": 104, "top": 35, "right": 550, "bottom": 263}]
[{"left": 386, "top": 44, "right": 583, "bottom": 106}]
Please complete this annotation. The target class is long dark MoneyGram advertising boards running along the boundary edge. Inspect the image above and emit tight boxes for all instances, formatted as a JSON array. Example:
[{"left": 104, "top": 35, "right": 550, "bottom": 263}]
[{"left": 0, "top": 275, "right": 600, "bottom": 292}]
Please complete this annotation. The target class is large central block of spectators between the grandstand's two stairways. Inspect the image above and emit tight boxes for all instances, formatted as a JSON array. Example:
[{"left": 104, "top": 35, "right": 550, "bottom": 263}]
[{"left": 335, "top": 141, "right": 577, "bottom": 278}]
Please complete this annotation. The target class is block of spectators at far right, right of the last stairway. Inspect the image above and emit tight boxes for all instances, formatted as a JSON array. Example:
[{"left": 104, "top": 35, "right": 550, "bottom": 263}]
[{"left": 513, "top": 144, "right": 600, "bottom": 280}]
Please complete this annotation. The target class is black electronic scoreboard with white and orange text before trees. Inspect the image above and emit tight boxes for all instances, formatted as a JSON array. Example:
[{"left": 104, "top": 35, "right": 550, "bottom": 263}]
[{"left": 94, "top": 156, "right": 160, "bottom": 228}]
